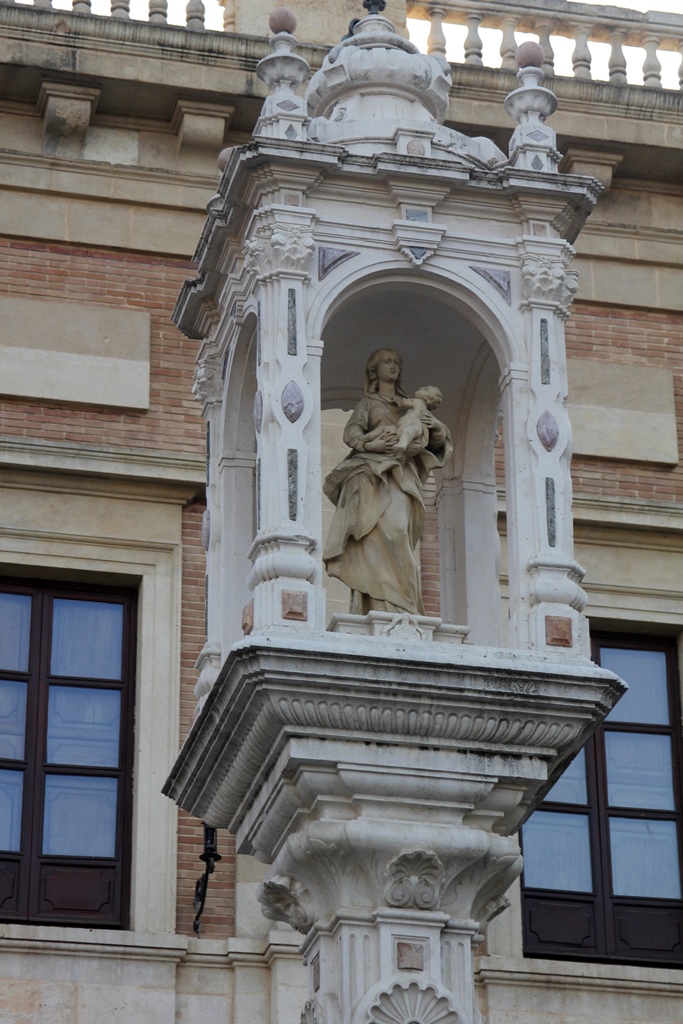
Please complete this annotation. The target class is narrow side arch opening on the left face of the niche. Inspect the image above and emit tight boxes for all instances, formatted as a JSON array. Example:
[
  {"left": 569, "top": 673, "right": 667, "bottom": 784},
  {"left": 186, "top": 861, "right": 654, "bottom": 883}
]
[{"left": 219, "top": 313, "right": 258, "bottom": 651}]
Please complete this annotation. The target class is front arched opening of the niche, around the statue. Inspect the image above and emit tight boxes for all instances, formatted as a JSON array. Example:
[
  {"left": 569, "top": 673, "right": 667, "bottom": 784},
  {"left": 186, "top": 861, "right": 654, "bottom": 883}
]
[{"left": 322, "top": 280, "right": 501, "bottom": 644}]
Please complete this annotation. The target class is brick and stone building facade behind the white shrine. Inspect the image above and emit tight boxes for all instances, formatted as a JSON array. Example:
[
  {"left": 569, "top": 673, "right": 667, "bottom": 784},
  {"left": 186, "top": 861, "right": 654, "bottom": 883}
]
[{"left": 0, "top": 0, "right": 683, "bottom": 1024}]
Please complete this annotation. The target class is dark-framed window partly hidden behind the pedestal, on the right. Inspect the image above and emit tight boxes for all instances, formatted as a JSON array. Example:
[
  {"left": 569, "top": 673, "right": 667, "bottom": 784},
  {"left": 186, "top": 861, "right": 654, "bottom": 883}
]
[{"left": 522, "top": 636, "right": 683, "bottom": 967}]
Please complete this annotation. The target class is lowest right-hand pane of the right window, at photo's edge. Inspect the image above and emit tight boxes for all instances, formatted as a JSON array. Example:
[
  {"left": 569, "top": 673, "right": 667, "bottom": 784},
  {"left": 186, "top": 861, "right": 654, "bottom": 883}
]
[{"left": 609, "top": 818, "right": 681, "bottom": 899}]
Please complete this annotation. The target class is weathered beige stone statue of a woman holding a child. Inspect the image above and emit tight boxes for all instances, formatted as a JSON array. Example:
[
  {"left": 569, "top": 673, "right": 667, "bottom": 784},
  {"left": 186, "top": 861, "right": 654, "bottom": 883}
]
[{"left": 323, "top": 348, "right": 453, "bottom": 615}]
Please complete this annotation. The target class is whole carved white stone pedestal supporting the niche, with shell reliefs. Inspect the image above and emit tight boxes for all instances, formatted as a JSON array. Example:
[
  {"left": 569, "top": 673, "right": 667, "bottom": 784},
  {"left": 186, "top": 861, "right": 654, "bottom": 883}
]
[{"left": 166, "top": 634, "right": 624, "bottom": 1024}]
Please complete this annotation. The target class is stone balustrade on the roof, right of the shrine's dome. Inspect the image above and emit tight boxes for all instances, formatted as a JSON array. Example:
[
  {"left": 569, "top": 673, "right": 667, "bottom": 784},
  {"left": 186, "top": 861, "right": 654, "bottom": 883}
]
[{"left": 408, "top": 0, "right": 683, "bottom": 90}]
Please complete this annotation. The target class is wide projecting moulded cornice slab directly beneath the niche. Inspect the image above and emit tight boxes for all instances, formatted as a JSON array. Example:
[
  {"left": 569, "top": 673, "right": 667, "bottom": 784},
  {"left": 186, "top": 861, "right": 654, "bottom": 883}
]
[{"left": 165, "top": 635, "right": 622, "bottom": 829}]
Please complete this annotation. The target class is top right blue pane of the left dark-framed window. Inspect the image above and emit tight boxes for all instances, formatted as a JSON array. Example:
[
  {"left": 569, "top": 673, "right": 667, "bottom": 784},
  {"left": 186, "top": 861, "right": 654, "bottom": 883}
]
[{"left": 51, "top": 598, "right": 123, "bottom": 679}]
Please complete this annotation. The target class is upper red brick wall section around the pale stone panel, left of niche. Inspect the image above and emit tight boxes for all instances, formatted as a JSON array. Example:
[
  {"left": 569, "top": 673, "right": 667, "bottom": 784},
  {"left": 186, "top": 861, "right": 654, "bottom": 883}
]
[{"left": 0, "top": 239, "right": 205, "bottom": 454}]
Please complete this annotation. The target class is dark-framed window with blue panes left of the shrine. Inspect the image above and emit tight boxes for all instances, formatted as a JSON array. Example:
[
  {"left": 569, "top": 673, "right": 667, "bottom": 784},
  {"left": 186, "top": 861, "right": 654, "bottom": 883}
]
[{"left": 0, "top": 581, "right": 136, "bottom": 928}]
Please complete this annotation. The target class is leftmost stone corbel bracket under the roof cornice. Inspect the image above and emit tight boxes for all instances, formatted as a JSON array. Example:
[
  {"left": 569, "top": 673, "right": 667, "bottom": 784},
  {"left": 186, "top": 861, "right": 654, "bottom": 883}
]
[{"left": 38, "top": 82, "right": 99, "bottom": 160}]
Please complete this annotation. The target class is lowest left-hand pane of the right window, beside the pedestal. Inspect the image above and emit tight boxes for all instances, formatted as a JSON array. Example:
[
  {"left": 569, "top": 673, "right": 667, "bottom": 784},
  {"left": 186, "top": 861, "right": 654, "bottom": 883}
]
[{"left": 523, "top": 811, "right": 593, "bottom": 893}]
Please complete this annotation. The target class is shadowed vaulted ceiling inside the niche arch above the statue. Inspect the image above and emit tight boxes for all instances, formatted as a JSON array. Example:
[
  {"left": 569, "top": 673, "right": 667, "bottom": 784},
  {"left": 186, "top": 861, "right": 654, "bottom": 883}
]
[{"left": 322, "top": 280, "right": 500, "bottom": 475}]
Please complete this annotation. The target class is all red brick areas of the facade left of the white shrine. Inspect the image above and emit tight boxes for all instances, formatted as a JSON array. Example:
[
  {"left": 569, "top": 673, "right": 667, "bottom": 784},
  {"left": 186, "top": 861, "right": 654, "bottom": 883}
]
[{"left": 0, "top": 239, "right": 234, "bottom": 937}]
